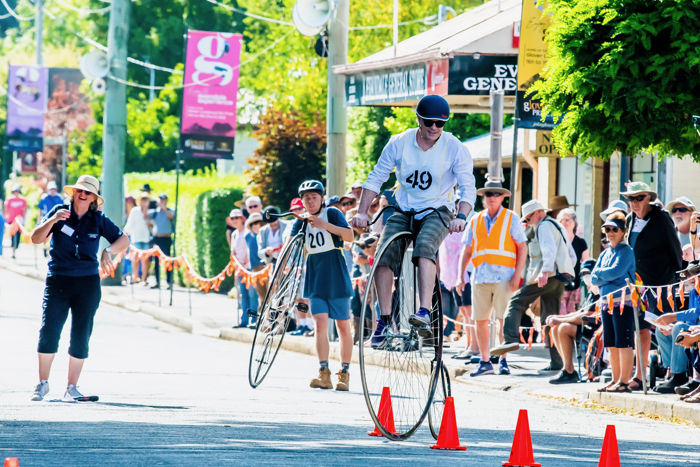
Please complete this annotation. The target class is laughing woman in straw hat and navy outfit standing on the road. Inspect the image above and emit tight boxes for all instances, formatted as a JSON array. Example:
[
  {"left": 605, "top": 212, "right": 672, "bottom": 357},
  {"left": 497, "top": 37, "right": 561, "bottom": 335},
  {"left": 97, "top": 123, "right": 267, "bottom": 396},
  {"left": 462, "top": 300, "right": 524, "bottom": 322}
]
[{"left": 27, "top": 175, "right": 129, "bottom": 402}]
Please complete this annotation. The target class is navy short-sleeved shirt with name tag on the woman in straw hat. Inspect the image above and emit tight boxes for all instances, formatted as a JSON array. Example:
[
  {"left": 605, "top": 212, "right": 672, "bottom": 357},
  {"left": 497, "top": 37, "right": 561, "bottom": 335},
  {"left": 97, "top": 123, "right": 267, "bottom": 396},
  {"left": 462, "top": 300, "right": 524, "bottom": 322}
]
[{"left": 42, "top": 204, "right": 123, "bottom": 277}]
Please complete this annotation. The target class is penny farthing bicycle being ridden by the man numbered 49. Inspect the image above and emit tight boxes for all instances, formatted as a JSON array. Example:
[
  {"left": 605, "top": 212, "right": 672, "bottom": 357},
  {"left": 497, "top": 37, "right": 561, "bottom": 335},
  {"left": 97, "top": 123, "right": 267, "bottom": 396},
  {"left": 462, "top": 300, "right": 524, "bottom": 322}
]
[{"left": 359, "top": 206, "right": 451, "bottom": 441}]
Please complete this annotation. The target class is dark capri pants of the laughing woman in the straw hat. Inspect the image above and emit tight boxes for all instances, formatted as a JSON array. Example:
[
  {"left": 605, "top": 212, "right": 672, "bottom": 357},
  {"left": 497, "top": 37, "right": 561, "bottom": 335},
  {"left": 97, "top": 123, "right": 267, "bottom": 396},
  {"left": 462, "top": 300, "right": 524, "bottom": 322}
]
[{"left": 37, "top": 275, "right": 102, "bottom": 358}]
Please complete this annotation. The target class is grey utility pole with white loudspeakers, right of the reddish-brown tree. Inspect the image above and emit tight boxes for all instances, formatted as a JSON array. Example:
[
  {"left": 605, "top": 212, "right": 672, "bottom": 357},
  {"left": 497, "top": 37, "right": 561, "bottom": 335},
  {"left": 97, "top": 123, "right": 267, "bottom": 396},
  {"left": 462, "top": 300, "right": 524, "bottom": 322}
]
[{"left": 326, "top": 0, "right": 350, "bottom": 196}]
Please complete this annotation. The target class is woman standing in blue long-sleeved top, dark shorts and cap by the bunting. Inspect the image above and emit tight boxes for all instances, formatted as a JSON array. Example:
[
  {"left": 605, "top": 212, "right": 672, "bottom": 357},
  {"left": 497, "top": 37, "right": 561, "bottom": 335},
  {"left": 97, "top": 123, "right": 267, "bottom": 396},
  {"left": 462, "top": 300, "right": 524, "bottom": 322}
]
[{"left": 591, "top": 213, "right": 635, "bottom": 392}]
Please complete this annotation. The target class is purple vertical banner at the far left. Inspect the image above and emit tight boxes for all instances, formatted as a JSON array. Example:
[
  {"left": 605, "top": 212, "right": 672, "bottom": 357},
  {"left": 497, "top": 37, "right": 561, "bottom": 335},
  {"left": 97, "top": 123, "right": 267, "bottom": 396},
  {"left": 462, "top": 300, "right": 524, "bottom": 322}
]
[{"left": 7, "top": 65, "right": 48, "bottom": 152}]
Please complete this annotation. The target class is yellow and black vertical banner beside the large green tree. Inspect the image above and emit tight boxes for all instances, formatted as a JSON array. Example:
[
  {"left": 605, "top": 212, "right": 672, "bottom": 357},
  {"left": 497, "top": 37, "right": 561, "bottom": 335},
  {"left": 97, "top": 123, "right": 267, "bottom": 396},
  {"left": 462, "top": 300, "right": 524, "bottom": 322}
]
[{"left": 515, "top": 0, "right": 555, "bottom": 130}]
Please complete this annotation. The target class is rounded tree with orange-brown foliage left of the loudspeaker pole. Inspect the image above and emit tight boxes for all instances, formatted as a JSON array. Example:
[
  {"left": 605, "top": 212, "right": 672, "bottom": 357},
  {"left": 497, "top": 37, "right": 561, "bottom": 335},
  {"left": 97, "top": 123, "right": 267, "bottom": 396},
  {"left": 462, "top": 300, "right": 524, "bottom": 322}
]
[{"left": 246, "top": 109, "right": 326, "bottom": 209}]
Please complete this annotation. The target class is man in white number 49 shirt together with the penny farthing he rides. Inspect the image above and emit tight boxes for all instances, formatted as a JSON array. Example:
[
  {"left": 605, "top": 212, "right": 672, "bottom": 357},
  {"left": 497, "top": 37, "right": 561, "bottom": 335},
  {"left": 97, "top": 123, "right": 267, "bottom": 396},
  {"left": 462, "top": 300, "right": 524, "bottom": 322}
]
[{"left": 352, "top": 95, "right": 476, "bottom": 440}]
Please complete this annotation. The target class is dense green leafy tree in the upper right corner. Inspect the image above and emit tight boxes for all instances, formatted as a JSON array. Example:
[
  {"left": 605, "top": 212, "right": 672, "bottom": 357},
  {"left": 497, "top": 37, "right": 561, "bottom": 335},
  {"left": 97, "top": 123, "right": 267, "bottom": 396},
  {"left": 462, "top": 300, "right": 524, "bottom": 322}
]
[{"left": 533, "top": 0, "right": 700, "bottom": 160}]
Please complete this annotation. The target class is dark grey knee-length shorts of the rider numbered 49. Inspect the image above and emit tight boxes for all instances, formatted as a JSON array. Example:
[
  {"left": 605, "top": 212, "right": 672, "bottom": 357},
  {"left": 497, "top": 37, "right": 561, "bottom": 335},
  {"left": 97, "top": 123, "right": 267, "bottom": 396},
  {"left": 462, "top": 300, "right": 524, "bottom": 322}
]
[{"left": 377, "top": 206, "right": 453, "bottom": 267}]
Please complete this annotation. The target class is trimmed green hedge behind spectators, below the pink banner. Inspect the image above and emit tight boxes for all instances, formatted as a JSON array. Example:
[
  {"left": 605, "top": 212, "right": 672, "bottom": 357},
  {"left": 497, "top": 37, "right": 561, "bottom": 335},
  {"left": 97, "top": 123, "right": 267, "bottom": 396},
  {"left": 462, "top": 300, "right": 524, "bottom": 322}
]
[{"left": 124, "top": 169, "right": 245, "bottom": 290}]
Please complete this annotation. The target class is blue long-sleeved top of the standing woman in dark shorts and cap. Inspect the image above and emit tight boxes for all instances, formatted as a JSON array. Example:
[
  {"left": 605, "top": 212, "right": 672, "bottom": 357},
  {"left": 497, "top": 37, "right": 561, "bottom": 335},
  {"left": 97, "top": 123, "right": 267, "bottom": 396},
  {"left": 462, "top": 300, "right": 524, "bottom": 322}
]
[{"left": 591, "top": 242, "right": 635, "bottom": 298}]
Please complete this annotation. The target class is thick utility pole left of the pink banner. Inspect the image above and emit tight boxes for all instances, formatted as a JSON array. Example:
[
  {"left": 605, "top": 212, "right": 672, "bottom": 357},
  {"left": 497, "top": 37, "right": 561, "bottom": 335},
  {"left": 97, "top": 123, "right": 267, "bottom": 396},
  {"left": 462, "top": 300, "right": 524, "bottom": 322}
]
[{"left": 102, "top": 0, "right": 131, "bottom": 285}]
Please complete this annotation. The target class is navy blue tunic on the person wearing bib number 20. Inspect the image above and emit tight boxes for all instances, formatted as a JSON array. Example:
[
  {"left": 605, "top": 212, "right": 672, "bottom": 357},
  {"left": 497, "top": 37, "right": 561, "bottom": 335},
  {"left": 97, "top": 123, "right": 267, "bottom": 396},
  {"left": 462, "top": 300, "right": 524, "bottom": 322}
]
[{"left": 291, "top": 208, "right": 352, "bottom": 299}]
